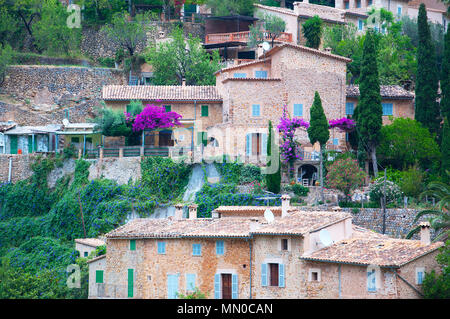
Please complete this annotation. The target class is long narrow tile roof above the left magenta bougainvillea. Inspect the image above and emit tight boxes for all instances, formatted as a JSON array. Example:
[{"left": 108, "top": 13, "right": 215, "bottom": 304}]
[{"left": 102, "top": 85, "right": 222, "bottom": 101}]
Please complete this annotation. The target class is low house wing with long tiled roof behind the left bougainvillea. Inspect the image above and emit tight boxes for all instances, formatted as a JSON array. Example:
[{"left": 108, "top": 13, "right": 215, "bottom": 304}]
[{"left": 102, "top": 85, "right": 222, "bottom": 148}]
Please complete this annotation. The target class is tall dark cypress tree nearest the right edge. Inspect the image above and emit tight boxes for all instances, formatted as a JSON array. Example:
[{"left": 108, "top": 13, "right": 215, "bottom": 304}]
[{"left": 415, "top": 3, "right": 440, "bottom": 135}]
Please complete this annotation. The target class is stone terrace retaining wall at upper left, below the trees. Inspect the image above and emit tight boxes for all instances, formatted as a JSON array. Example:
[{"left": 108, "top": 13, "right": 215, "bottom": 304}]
[{"left": 0, "top": 65, "right": 126, "bottom": 125}]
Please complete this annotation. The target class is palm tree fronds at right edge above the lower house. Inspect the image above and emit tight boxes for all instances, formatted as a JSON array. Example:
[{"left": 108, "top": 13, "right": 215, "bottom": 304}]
[{"left": 406, "top": 171, "right": 450, "bottom": 241}]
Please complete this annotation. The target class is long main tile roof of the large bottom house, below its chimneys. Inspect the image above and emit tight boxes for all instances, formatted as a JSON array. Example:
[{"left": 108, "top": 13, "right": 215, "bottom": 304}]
[{"left": 106, "top": 210, "right": 351, "bottom": 238}]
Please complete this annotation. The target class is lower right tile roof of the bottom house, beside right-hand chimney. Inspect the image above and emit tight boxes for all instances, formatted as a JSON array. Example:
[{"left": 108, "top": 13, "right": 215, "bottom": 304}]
[{"left": 301, "top": 236, "right": 444, "bottom": 267}]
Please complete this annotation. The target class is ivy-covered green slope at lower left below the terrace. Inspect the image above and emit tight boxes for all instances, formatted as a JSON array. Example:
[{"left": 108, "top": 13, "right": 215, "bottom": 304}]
[{"left": 0, "top": 156, "right": 195, "bottom": 298}]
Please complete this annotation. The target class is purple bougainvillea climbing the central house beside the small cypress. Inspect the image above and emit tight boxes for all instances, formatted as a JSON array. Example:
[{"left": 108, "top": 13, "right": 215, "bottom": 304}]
[{"left": 277, "top": 105, "right": 309, "bottom": 162}]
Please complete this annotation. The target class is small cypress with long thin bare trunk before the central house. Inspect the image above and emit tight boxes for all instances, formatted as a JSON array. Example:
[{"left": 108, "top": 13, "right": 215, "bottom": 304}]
[{"left": 308, "top": 91, "right": 330, "bottom": 201}]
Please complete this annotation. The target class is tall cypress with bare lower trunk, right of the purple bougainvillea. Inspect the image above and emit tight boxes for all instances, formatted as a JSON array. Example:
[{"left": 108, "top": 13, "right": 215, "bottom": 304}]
[{"left": 355, "top": 30, "right": 383, "bottom": 176}]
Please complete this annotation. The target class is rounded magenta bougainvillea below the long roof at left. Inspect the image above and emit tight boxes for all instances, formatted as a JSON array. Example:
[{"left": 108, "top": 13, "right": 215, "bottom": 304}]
[{"left": 132, "top": 104, "right": 182, "bottom": 132}]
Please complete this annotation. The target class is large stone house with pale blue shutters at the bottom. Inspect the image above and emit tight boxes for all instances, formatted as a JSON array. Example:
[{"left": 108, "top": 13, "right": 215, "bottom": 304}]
[{"left": 90, "top": 196, "right": 443, "bottom": 299}]
